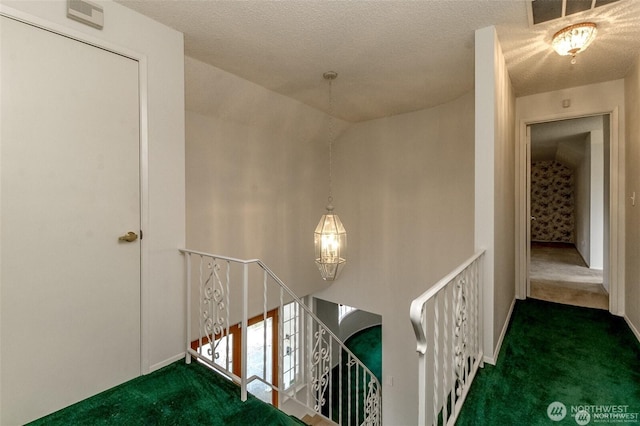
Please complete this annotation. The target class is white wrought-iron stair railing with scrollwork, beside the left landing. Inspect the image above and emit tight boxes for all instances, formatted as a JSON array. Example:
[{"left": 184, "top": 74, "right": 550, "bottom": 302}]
[{"left": 179, "top": 249, "right": 382, "bottom": 425}]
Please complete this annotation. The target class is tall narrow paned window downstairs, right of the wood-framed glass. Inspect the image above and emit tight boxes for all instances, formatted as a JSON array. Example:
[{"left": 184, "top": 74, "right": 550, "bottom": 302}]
[{"left": 282, "top": 302, "right": 301, "bottom": 389}]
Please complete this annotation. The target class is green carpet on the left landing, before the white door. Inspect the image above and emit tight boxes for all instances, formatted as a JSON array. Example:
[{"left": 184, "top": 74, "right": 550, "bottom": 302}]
[{"left": 30, "top": 361, "right": 304, "bottom": 426}]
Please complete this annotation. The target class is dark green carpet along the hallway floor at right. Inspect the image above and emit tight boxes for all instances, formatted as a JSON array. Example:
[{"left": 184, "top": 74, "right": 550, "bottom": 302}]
[{"left": 457, "top": 299, "right": 640, "bottom": 426}]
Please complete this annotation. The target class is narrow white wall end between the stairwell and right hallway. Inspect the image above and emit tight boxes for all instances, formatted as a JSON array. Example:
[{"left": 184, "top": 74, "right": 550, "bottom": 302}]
[{"left": 475, "top": 27, "right": 515, "bottom": 363}]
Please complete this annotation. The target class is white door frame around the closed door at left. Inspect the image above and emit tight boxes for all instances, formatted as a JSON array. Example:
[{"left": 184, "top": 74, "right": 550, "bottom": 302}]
[{"left": 0, "top": 3, "right": 150, "bottom": 374}]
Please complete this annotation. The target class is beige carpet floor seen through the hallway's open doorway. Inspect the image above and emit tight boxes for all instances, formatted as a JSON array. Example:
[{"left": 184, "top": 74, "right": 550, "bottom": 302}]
[{"left": 529, "top": 243, "right": 609, "bottom": 309}]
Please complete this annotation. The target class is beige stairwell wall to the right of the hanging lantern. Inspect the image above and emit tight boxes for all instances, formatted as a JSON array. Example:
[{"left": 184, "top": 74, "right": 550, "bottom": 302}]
[{"left": 316, "top": 93, "right": 474, "bottom": 425}]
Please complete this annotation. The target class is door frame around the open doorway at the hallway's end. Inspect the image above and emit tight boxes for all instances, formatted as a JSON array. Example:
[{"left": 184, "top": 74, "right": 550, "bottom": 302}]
[{"left": 515, "top": 106, "right": 625, "bottom": 315}]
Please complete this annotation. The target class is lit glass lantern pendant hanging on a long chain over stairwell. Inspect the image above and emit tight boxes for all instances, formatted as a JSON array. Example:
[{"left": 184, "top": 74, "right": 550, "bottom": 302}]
[{"left": 313, "top": 71, "right": 347, "bottom": 281}]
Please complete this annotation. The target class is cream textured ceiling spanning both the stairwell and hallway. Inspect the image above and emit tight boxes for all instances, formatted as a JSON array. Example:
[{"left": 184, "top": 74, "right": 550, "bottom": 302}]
[{"left": 117, "top": 0, "right": 640, "bottom": 121}]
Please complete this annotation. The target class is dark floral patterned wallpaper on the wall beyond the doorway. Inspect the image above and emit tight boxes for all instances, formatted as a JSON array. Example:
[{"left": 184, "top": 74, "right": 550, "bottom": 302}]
[{"left": 531, "top": 161, "right": 575, "bottom": 243}]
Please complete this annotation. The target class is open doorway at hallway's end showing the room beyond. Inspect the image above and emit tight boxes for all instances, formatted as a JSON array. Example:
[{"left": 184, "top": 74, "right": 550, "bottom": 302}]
[{"left": 527, "top": 114, "right": 611, "bottom": 309}]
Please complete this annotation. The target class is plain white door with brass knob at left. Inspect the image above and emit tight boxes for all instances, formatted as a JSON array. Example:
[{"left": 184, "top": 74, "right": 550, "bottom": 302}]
[{"left": 0, "top": 17, "right": 141, "bottom": 425}]
